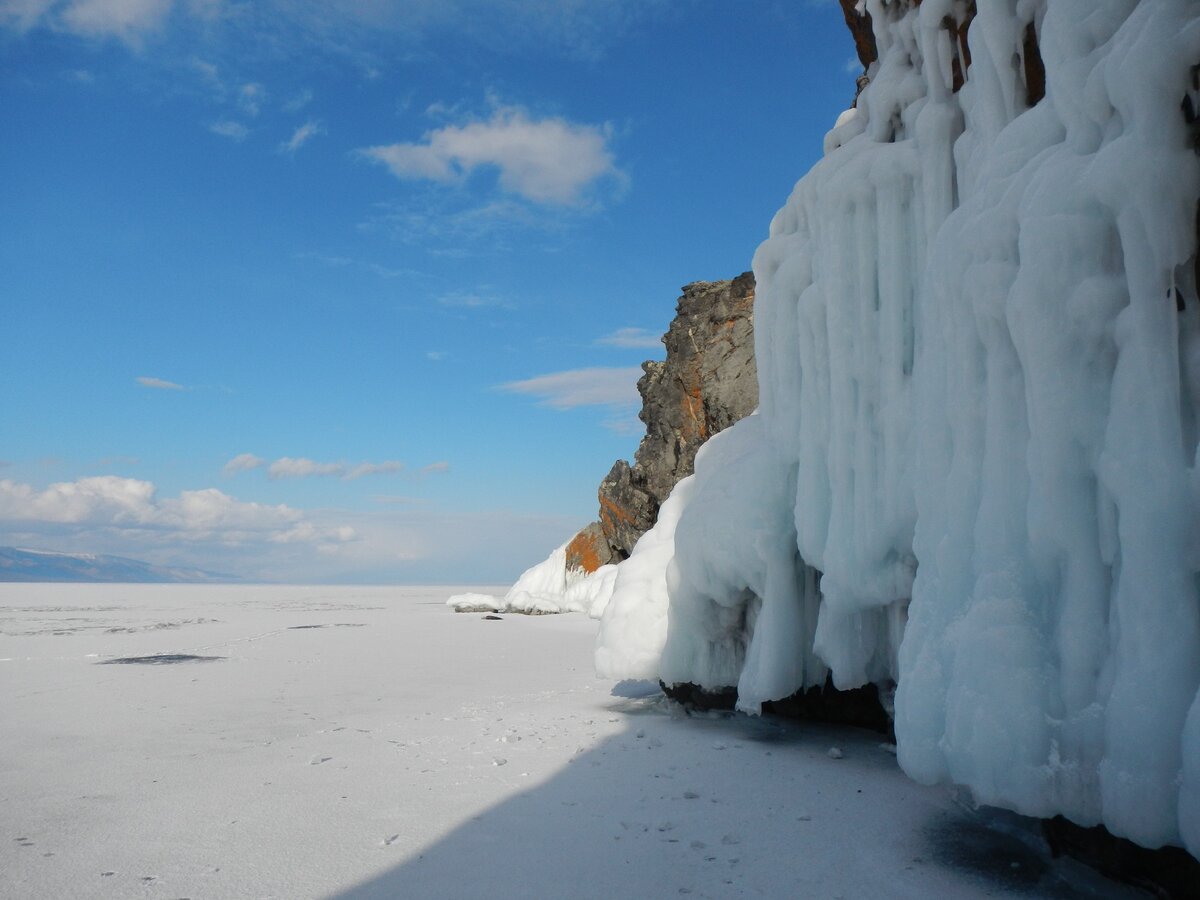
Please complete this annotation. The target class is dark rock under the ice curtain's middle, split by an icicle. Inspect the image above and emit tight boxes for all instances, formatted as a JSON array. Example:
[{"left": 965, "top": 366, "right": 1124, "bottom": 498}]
[{"left": 662, "top": 678, "right": 895, "bottom": 740}]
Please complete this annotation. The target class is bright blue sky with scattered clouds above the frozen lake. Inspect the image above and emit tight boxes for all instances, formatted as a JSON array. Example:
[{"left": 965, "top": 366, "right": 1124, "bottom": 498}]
[{"left": 0, "top": 0, "right": 856, "bottom": 583}]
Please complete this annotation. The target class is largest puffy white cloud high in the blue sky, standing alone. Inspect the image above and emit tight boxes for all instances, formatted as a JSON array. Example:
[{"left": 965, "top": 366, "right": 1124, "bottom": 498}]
[{"left": 359, "top": 106, "right": 623, "bottom": 206}]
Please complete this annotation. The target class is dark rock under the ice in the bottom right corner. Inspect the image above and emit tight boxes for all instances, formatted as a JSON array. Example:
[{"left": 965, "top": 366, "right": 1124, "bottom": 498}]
[{"left": 1042, "top": 816, "right": 1200, "bottom": 900}]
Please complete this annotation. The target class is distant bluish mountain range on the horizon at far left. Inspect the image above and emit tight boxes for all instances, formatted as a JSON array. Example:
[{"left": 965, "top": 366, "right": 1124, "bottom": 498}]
[{"left": 0, "top": 547, "right": 241, "bottom": 584}]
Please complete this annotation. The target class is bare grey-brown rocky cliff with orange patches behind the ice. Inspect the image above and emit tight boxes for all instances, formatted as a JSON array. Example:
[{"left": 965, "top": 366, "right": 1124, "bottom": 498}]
[{"left": 568, "top": 272, "right": 758, "bottom": 571}]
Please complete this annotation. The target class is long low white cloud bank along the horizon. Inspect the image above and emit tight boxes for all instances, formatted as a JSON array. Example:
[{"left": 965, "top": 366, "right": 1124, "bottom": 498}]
[{"left": 0, "top": 478, "right": 580, "bottom": 583}]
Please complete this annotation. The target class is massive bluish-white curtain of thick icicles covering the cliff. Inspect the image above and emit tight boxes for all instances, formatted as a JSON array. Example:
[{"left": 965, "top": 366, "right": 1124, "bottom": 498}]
[{"left": 596, "top": 0, "right": 1200, "bottom": 853}]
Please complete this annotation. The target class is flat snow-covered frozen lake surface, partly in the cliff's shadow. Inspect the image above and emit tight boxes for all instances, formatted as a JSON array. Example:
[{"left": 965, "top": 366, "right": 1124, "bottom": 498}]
[{"left": 0, "top": 584, "right": 1139, "bottom": 899}]
